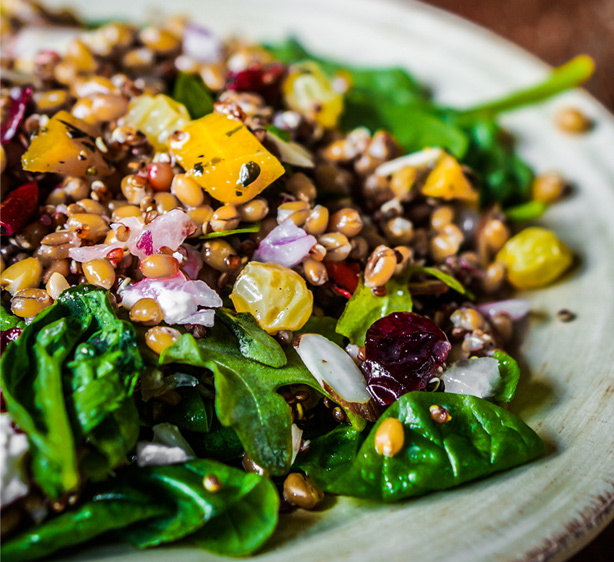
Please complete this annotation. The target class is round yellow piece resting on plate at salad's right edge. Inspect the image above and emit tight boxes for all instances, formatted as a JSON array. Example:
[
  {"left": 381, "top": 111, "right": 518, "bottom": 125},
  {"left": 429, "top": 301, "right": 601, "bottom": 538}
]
[{"left": 497, "top": 226, "right": 573, "bottom": 289}]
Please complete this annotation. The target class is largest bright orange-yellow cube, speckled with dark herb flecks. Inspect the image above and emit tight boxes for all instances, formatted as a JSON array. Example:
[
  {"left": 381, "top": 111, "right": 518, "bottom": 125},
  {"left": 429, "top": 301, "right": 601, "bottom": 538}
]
[{"left": 170, "top": 113, "right": 284, "bottom": 205}]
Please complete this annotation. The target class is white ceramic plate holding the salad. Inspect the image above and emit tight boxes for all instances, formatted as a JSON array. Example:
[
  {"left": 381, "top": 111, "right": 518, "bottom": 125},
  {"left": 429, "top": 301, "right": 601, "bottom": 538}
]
[{"left": 44, "top": 0, "right": 614, "bottom": 562}]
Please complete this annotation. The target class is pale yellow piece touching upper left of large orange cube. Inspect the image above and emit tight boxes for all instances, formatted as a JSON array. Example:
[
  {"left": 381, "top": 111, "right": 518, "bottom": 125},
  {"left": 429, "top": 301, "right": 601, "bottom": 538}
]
[{"left": 124, "top": 94, "right": 190, "bottom": 151}]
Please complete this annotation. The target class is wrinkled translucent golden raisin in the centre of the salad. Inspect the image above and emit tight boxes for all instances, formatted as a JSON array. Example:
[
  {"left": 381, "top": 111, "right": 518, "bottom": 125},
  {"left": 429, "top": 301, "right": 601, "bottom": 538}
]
[{"left": 230, "top": 261, "right": 313, "bottom": 334}]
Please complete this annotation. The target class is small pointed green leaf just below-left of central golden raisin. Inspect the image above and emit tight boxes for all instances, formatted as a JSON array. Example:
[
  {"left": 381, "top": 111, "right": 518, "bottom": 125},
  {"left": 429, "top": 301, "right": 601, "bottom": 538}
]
[{"left": 216, "top": 308, "right": 287, "bottom": 367}]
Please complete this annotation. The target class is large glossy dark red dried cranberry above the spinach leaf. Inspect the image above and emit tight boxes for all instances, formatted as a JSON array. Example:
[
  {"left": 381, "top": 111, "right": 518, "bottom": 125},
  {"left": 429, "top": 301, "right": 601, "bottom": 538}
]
[{"left": 362, "top": 312, "right": 452, "bottom": 405}]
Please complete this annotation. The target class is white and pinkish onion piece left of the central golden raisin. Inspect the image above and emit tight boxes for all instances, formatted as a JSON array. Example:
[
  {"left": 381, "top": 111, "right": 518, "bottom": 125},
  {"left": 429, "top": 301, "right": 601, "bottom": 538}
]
[{"left": 122, "top": 273, "right": 222, "bottom": 326}]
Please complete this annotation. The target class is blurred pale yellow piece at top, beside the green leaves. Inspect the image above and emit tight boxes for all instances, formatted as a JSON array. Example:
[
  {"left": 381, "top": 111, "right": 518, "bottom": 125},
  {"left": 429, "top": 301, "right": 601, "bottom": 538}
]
[{"left": 282, "top": 61, "right": 343, "bottom": 129}]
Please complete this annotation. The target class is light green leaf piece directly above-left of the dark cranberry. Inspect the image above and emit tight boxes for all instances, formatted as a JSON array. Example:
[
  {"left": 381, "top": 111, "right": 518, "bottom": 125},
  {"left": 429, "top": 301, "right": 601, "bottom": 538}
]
[{"left": 337, "top": 277, "right": 413, "bottom": 345}]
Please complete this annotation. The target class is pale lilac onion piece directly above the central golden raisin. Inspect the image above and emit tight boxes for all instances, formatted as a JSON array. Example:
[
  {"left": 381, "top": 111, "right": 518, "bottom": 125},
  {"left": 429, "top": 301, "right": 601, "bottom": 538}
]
[{"left": 253, "top": 219, "right": 318, "bottom": 268}]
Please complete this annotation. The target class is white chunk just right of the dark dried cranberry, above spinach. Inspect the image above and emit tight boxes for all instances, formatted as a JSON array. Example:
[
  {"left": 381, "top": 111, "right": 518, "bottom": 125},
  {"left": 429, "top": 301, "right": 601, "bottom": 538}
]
[{"left": 441, "top": 357, "right": 501, "bottom": 399}]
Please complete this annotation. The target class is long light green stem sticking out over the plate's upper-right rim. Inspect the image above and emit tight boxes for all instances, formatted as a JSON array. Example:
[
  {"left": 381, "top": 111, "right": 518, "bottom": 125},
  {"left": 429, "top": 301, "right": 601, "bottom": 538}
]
[{"left": 461, "top": 55, "right": 595, "bottom": 116}]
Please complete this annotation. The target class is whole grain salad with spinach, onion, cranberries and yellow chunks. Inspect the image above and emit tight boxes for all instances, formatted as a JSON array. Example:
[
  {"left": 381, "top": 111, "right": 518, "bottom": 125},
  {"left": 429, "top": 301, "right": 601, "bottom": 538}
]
[{"left": 0, "top": 0, "right": 593, "bottom": 561}]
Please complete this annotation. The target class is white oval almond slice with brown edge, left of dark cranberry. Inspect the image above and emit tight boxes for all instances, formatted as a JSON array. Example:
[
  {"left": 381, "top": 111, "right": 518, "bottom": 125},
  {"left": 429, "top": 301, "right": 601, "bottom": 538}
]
[{"left": 294, "top": 334, "right": 374, "bottom": 419}]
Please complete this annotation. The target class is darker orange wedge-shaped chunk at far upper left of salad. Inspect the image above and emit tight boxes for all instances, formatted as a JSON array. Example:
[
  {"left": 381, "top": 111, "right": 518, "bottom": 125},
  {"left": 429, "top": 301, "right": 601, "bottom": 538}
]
[{"left": 21, "top": 110, "right": 113, "bottom": 176}]
